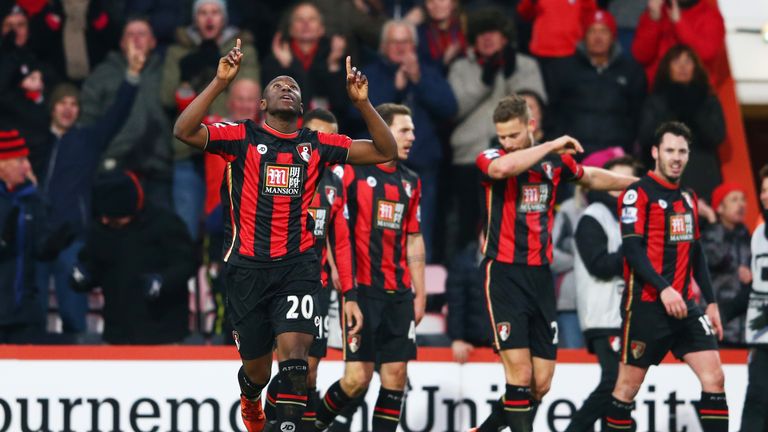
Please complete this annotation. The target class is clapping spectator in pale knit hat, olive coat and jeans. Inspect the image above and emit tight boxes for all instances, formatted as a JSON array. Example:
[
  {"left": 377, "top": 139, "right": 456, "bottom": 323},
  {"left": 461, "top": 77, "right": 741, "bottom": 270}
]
[{"left": 160, "top": 0, "right": 259, "bottom": 240}]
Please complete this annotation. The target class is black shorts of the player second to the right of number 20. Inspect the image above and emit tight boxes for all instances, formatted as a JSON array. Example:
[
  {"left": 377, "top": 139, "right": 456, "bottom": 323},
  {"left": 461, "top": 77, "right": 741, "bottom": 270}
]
[{"left": 340, "top": 287, "right": 416, "bottom": 363}]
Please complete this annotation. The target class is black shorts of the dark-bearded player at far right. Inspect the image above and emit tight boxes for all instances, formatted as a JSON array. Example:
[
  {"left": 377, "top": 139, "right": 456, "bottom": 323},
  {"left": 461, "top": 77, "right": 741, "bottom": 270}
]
[{"left": 621, "top": 302, "right": 717, "bottom": 368}]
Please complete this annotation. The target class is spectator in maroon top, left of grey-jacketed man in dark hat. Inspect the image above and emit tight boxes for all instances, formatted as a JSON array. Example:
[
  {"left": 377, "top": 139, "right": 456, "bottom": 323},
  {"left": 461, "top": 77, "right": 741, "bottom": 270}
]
[{"left": 418, "top": 0, "right": 467, "bottom": 74}]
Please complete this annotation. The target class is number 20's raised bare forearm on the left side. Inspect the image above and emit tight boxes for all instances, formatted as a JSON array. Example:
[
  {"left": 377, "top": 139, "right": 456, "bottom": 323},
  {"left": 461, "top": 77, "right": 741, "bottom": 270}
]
[{"left": 173, "top": 78, "right": 228, "bottom": 149}]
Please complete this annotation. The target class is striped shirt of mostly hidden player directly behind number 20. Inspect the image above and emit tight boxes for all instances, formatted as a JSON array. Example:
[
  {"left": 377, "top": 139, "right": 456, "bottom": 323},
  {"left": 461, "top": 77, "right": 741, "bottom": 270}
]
[{"left": 309, "top": 165, "right": 354, "bottom": 293}]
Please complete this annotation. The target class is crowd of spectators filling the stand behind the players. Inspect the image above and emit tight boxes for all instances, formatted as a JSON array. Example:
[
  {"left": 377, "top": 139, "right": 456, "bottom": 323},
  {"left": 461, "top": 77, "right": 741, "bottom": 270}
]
[{"left": 0, "top": 0, "right": 757, "bottom": 352}]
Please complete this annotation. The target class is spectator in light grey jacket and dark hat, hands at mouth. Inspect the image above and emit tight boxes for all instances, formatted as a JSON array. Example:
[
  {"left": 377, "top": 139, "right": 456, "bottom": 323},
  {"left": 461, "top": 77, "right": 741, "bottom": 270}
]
[{"left": 448, "top": 8, "right": 546, "bottom": 248}]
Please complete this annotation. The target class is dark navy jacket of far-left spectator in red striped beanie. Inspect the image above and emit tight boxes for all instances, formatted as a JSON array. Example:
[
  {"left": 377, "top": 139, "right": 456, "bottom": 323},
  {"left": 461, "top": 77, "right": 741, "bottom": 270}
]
[{"left": 0, "top": 183, "right": 43, "bottom": 325}]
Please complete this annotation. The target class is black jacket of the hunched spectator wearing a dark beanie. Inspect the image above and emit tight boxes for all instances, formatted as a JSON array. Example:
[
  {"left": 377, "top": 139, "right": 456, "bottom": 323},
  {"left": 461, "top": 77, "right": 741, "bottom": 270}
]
[{"left": 80, "top": 207, "right": 195, "bottom": 344}]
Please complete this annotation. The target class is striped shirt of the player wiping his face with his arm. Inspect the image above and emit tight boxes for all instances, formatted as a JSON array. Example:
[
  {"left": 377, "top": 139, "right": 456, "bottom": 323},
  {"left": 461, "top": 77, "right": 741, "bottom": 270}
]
[{"left": 477, "top": 148, "right": 584, "bottom": 266}]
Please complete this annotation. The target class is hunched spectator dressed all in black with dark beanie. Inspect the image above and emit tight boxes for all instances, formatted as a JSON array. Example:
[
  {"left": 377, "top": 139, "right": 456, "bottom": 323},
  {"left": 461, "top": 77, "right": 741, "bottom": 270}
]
[{"left": 72, "top": 171, "right": 195, "bottom": 345}]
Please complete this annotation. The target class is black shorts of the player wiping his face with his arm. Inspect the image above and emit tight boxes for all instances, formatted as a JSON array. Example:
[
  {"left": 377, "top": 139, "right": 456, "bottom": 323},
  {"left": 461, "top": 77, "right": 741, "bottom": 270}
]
[{"left": 483, "top": 258, "right": 557, "bottom": 360}]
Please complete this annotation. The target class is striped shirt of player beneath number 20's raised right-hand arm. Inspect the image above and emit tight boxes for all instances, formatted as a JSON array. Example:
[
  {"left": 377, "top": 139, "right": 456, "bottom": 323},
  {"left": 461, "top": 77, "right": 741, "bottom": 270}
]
[{"left": 343, "top": 164, "right": 421, "bottom": 294}]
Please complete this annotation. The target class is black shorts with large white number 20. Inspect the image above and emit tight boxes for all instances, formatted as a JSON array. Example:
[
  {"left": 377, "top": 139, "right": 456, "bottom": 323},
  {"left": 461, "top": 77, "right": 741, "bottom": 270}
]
[{"left": 225, "top": 260, "right": 320, "bottom": 360}]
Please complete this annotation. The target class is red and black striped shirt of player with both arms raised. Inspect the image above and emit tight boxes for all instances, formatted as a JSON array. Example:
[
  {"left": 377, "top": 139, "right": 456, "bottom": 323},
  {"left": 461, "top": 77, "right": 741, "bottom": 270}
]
[{"left": 205, "top": 120, "right": 352, "bottom": 266}]
